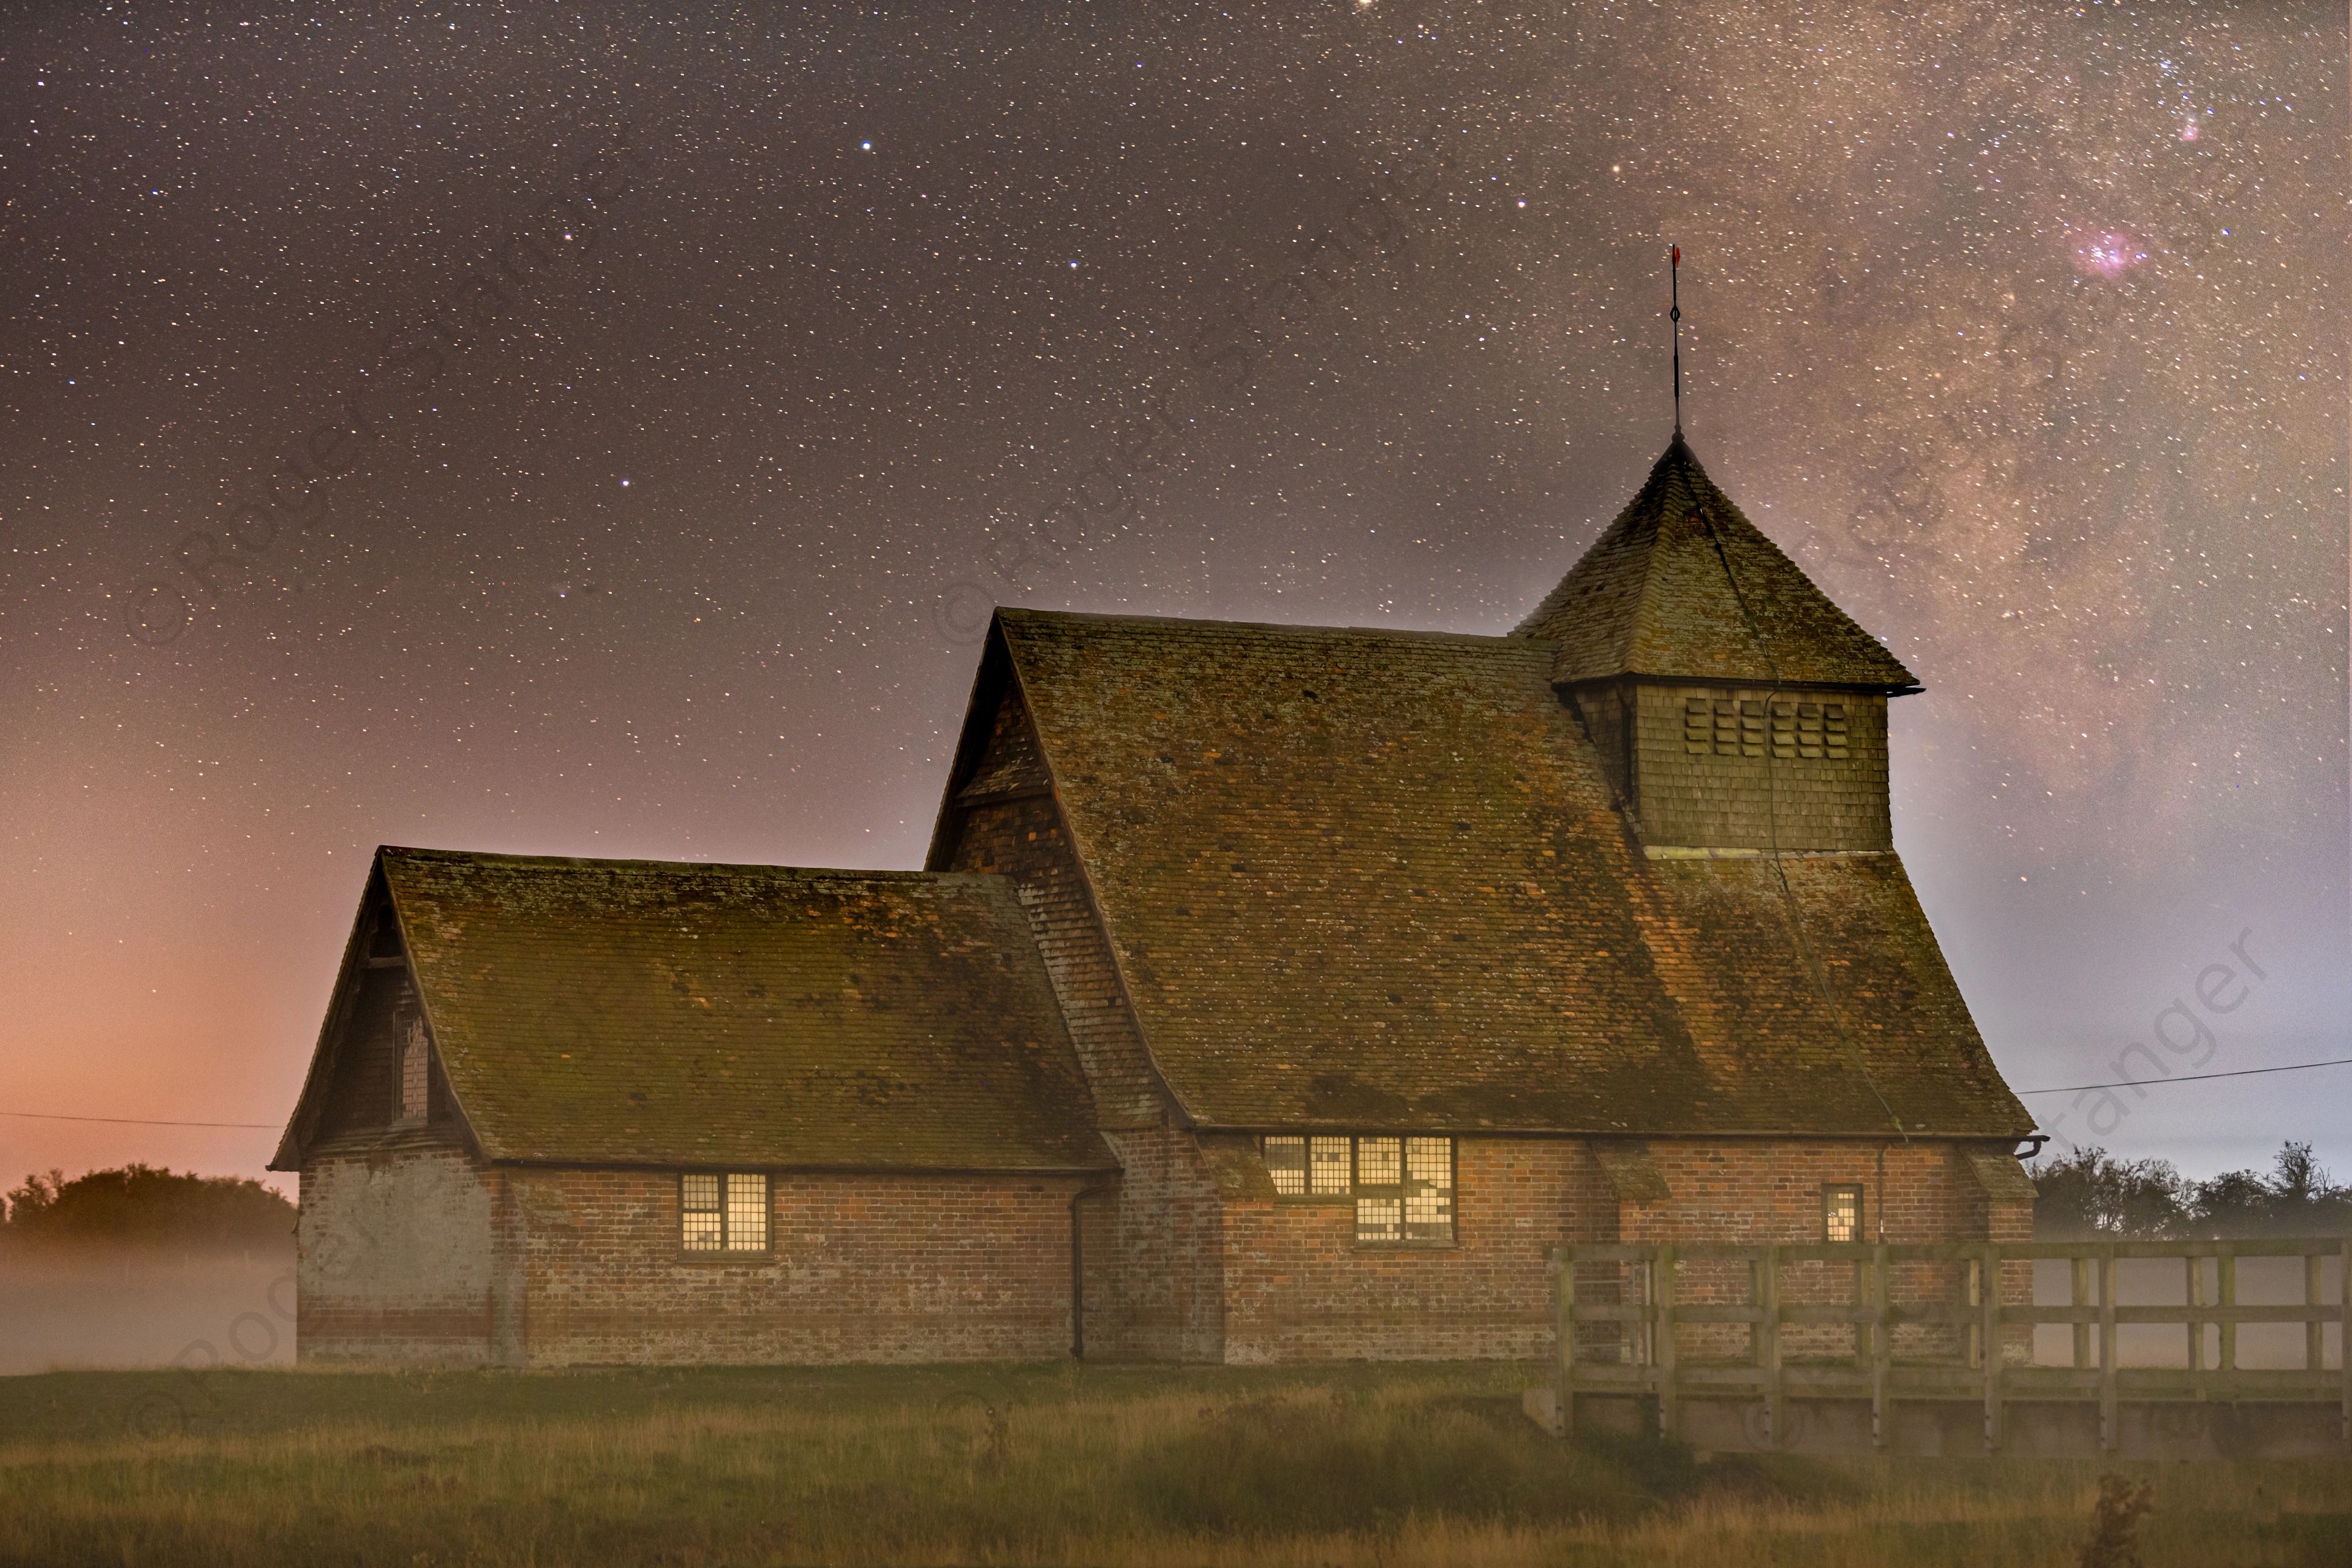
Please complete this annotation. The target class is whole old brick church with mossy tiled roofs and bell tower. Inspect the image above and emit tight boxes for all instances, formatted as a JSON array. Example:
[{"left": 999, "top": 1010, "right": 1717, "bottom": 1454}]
[{"left": 271, "top": 435, "right": 2032, "bottom": 1366}]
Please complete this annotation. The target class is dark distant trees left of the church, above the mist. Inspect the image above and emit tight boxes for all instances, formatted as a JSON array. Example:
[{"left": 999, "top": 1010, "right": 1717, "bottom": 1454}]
[{"left": 0, "top": 1166, "right": 294, "bottom": 1248}]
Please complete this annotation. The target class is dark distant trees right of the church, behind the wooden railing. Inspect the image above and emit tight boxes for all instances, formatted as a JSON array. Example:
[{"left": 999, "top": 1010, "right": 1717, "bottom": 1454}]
[{"left": 2025, "top": 1142, "right": 2352, "bottom": 1242}]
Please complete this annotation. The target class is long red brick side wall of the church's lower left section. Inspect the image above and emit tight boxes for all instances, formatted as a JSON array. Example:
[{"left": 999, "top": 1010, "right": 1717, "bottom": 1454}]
[{"left": 510, "top": 1170, "right": 1082, "bottom": 1366}]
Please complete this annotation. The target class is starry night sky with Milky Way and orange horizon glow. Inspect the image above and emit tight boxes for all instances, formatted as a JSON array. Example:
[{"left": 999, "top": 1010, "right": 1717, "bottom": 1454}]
[{"left": 0, "top": 0, "right": 2352, "bottom": 1183}]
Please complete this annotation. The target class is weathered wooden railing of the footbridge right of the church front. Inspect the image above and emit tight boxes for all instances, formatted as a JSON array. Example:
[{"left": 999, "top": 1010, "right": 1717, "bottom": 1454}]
[{"left": 1529, "top": 1237, "right": 2352, "bottom": 1458}]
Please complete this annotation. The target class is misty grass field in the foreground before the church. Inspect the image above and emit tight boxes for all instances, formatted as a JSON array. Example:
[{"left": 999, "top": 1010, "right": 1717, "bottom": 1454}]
[{"left": 0, "top": 1363, "right": 2352, "bottom": 1568}]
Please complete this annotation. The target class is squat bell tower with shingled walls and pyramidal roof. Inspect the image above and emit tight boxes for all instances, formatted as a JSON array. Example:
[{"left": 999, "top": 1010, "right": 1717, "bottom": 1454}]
[{"left": 1512, "top": 430, "right": 1919, "bottom": 856}]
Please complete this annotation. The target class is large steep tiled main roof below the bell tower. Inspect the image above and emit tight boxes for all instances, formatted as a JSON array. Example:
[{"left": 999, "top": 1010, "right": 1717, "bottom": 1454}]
[{"left": 997, "top": 611, "right": 2032, "bottom": 1136}]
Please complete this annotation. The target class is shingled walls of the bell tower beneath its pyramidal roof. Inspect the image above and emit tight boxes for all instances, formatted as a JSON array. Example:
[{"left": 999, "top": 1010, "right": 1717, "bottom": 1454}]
[{"left": 1576, "top": 682, "right": 1893, "bottom": 849}]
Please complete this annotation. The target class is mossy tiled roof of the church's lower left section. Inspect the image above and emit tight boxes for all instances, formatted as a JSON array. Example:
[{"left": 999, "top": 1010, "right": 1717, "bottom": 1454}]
[{"left": 357, "top": 849, "right": 1112, "bottom": 1170}]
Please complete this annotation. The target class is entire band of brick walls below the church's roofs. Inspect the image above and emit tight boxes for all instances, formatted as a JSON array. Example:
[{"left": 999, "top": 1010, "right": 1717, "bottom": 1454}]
[{"left": 299, "top": 1131, "right": 2032, "bottom": 1366}]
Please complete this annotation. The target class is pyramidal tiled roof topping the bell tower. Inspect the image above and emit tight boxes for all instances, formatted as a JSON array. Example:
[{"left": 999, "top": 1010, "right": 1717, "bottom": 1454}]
[{"left": 1512, "top": 430, "right": 1919, "bottom": 691}]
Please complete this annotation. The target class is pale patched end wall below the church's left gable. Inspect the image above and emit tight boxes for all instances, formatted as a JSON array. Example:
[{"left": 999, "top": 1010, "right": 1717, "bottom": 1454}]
[{"left": 294, "top": 1133, "right": 496, "bottom": 1366}]
